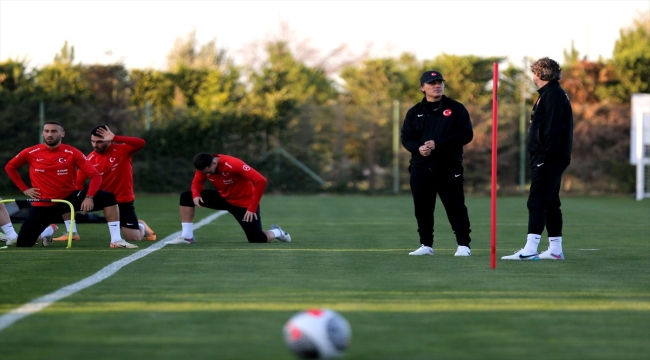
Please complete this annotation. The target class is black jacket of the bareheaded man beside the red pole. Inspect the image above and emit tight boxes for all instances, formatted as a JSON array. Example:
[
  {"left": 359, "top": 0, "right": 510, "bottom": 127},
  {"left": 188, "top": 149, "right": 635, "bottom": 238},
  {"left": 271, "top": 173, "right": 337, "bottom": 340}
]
[{"left": 528, "top": 80, "right": 573, "bottom": 166}]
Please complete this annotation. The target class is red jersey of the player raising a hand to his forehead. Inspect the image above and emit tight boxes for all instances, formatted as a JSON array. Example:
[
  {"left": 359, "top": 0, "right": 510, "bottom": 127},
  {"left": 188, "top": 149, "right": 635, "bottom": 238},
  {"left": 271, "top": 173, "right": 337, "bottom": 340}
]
[{"left": 77, "top": 135, "right": 145, "bottom": 203}]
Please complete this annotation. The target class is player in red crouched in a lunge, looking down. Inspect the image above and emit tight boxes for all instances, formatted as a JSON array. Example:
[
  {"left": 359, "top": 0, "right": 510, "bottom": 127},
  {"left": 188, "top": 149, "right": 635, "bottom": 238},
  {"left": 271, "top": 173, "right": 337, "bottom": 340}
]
[{"left": 168, "top": 153, "right": 291, "bottom": 244}]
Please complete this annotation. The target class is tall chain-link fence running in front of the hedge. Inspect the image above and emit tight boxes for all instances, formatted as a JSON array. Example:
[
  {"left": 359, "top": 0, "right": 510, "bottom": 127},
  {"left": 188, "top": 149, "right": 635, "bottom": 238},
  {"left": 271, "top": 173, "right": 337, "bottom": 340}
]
[{"left": 0, "top": 101, "right": 633, "bottom": 194}]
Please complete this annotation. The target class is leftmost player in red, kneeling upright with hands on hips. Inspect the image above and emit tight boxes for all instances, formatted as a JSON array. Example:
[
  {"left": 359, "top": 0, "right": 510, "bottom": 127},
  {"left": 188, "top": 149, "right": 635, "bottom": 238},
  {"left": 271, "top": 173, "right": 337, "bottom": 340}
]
[{"left": 5, "top": 121, "right": 137, "bottom": 248}]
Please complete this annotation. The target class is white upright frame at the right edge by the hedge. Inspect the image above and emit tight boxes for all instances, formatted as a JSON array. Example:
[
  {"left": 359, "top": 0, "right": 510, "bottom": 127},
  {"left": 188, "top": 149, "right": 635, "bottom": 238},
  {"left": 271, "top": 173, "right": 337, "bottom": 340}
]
[{"left": 630, "top": 94, "right": 650, "bottom": 200}]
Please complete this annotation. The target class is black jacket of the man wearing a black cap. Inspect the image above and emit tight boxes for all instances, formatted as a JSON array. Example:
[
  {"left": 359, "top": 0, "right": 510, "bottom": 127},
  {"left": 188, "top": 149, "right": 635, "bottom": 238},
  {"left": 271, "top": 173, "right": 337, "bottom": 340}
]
[{"left": 401, "top": 95, "right": 474, "bottom": 171}]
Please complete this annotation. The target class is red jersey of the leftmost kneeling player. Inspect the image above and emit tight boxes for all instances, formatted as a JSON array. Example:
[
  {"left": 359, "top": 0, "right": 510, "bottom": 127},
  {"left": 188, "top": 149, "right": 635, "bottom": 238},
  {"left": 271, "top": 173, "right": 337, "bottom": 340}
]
[{"left": 5, "top": 144, "right": 102, "bottom": 206}]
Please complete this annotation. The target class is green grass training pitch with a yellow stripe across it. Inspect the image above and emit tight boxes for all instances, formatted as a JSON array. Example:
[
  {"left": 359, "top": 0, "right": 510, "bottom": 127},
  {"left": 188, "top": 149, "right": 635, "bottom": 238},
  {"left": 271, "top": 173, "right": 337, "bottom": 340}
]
[{"left": 0, "top": 195, "right": 650, "bottom": 360}]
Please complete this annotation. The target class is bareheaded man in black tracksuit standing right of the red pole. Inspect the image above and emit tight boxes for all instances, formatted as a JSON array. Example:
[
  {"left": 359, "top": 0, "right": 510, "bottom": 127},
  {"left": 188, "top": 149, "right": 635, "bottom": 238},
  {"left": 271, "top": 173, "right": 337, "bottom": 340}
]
[{"left": 502, "top": 57, "right": 573, "bottom": 260}]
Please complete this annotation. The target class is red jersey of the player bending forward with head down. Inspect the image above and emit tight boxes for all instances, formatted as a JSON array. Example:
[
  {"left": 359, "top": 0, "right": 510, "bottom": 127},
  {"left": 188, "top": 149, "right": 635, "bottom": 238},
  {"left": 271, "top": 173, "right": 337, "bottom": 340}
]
[{"left": 192, "top": 154, "right": 266, "bottom": 212}]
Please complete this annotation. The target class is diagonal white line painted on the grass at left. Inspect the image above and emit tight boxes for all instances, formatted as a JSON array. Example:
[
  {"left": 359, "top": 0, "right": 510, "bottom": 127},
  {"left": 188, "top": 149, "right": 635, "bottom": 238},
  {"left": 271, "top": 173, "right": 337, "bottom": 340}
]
[{"left": 0, "top": 211, "right": 228, "bottom": 331}]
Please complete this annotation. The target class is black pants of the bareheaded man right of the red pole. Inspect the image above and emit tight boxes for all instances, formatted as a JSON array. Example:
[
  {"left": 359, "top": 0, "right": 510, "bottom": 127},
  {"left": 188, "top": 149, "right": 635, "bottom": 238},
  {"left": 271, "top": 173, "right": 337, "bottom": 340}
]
[{"left": 528, "top": 162, "right": 569, "bottom": 237}]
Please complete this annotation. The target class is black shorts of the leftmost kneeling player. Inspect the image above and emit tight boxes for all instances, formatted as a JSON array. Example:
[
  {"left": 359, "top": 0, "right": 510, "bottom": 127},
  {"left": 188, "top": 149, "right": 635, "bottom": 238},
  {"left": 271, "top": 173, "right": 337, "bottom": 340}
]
[{"left": 16, "top": 190, "right": 117, "bottom": 247}]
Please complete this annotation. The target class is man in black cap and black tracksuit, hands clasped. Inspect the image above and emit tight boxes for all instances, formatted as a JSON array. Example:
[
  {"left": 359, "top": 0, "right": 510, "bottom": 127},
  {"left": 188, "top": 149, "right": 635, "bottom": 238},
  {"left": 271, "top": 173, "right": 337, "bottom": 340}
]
[{"left": 401, "top": 71, "right": 474, "bottom": 256}]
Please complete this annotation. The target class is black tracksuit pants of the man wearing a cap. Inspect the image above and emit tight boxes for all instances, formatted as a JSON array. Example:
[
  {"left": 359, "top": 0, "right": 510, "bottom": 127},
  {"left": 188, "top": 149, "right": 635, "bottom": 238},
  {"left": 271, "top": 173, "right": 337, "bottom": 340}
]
[{"left": 409, "top": 165, "right": 471, "bottom": 246}]
